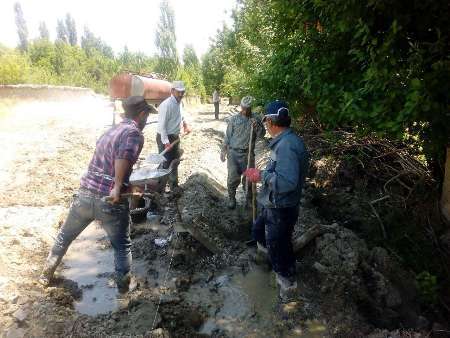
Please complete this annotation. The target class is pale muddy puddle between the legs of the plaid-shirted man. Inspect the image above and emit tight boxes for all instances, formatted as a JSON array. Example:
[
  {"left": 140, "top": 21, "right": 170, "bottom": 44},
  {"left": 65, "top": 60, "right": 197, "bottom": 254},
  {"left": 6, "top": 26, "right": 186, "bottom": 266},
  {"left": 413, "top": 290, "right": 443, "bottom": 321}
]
[{"left": 63, "top": 223, "right": 119, "bottom": 316}]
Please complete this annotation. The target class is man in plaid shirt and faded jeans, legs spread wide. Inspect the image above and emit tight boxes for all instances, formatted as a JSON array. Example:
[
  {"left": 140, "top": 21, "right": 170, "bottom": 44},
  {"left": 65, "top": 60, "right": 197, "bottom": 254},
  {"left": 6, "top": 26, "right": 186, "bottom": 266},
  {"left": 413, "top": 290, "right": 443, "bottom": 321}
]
[{"left": 39, "top": 96, "right": 156, "bottom": 292}]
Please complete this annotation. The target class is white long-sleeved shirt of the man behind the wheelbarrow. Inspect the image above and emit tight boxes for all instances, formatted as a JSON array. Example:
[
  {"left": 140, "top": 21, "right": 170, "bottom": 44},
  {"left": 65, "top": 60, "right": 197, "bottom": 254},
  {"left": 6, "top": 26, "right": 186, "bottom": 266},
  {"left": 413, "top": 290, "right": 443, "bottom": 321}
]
[{"left": 156, "top": 95, "right": 184, "bottom": 144}]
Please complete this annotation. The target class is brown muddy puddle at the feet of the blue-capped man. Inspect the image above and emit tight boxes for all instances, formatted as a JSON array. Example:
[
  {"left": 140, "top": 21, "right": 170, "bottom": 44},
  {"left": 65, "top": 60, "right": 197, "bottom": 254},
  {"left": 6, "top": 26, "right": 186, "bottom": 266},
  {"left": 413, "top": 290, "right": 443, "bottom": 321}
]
[{"left": 186, "top": 266, "right": 277, "bottom": 337}]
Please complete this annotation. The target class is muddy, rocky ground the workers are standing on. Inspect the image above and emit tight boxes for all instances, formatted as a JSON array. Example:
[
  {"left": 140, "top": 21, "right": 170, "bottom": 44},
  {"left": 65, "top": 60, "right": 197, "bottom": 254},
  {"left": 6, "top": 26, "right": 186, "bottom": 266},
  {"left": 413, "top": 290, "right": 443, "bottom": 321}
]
[{"left": 0, "top": 95, "right": 448, "bottom": 337}]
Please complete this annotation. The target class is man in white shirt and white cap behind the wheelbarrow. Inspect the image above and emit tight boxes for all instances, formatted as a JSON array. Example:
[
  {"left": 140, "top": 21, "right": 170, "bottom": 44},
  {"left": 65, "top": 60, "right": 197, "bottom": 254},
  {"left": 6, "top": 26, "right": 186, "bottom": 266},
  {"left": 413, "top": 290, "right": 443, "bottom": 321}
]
[{"left": 156, "top": 81, "right": 191, "bottom": 190}]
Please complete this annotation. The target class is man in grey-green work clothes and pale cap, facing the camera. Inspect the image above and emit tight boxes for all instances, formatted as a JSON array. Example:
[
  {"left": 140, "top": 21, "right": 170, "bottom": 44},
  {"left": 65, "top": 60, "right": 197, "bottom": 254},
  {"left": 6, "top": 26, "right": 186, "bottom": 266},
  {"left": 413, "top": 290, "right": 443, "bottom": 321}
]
[{"left": 220, "top": 96, "right": 265, "bottom": 209}]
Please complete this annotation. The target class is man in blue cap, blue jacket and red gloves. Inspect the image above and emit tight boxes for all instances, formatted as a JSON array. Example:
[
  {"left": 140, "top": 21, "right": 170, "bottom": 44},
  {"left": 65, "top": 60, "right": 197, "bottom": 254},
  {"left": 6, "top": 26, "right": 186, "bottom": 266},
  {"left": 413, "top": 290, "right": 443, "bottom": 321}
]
[{"left": 244, "top": 101, "right": 309, "bottom": 300}]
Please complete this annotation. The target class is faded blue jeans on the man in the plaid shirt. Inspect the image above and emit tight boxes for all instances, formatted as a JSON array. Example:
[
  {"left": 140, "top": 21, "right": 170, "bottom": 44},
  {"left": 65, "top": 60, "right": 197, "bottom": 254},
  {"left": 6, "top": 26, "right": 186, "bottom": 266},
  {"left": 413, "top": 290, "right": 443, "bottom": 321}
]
[{"left": 51, "top": 193, "right": 131, "bottom": 276}]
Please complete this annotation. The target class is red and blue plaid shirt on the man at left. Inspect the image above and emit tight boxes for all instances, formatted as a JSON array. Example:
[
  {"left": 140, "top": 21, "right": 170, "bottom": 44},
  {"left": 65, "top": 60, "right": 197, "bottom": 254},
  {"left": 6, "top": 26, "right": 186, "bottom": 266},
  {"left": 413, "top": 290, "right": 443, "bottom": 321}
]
[{"left": 80, "top": 118, "right": 144, "bottom": 195}]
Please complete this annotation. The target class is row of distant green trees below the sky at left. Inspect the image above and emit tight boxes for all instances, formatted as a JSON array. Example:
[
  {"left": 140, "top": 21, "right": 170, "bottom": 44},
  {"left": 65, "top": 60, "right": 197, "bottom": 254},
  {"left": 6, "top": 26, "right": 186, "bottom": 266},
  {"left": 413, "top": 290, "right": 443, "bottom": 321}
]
[{"left": 0, "top": 0, "right": 206, "bottom": 98}]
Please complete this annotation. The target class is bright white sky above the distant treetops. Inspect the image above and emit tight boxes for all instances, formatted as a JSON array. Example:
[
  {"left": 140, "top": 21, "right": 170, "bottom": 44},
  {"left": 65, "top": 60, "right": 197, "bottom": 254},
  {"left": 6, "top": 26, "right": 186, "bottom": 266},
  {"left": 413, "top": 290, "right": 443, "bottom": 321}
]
[{"left": 0, "top": 0, "right": 236, "bottom": 57}]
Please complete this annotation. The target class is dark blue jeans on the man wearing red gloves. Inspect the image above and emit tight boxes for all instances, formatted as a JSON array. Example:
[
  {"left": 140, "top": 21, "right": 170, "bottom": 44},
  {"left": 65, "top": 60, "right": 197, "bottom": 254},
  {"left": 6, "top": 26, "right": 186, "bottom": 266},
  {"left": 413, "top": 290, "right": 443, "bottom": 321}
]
[{"left": 252, "top": 206, "right": 299, "bottom": 278}]
